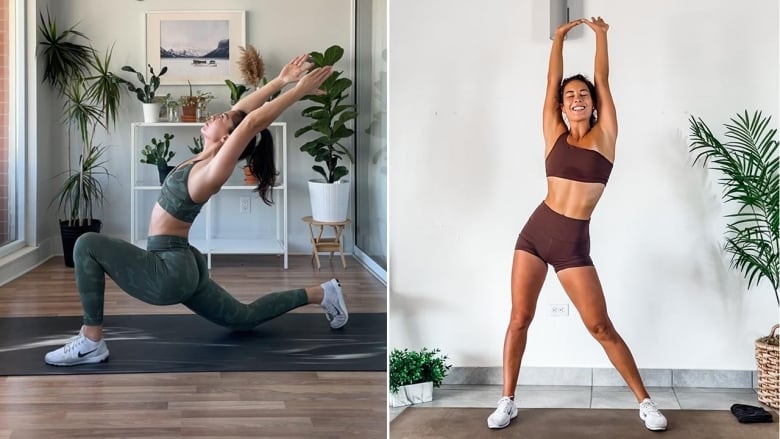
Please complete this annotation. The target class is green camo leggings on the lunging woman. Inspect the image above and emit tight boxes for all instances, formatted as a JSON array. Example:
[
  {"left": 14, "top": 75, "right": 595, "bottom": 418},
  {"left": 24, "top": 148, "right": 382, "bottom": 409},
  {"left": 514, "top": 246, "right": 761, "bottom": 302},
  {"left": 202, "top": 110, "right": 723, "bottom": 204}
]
[{"left": 73, "top": 232, "right": 308, "bottom": 331}]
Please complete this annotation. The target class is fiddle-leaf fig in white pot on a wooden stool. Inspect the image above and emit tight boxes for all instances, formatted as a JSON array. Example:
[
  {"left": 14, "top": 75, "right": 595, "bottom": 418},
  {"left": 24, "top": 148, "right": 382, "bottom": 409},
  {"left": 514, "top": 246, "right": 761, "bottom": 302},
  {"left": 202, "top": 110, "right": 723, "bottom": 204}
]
[{"left": 295, "top": 45, "right": 357, "bottom": 222}]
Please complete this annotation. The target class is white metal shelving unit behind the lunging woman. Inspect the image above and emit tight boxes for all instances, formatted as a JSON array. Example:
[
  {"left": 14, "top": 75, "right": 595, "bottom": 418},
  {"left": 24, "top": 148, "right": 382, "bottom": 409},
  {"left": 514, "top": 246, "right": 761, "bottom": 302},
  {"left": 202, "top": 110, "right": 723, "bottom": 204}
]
[{"left": 130, "top": 122, "right": 288, "bottom": 270}]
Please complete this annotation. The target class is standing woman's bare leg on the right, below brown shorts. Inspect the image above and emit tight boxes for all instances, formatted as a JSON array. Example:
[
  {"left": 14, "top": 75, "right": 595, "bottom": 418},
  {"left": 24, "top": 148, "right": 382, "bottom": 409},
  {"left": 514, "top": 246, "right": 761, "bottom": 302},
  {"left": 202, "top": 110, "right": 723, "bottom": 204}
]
[{"left": 558, "top": 266, "right": 649, "bottom": 402}]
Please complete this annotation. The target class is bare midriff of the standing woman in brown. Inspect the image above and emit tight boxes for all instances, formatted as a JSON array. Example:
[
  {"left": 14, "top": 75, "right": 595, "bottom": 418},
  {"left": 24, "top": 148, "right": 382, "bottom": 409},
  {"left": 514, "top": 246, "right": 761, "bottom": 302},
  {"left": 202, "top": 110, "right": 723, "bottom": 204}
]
[{"left": 544, "top": 177, "right": 605, "bottom": 220}]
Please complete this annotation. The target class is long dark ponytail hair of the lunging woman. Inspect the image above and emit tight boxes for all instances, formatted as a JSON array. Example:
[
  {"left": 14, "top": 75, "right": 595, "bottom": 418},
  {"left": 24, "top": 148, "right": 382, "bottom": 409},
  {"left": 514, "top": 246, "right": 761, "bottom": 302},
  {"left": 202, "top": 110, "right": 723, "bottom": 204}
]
[{"left": 233, "top": 111, "right": 279, "bottom": 206}]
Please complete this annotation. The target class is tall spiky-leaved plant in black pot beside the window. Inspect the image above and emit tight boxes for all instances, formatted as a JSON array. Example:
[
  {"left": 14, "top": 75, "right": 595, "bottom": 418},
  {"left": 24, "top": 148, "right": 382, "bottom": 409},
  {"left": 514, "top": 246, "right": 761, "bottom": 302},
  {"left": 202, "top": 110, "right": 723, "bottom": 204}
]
[{"left": 38, "top": 11, "right": 122, "bottom": 267}]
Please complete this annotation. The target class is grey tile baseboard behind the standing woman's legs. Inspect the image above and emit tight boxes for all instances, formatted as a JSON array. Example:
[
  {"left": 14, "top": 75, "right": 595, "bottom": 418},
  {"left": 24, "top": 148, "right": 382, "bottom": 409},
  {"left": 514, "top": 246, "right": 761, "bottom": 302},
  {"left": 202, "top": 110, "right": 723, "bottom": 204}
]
[{"left": 444, "top": 367, "right": 757, "bottom": 389}]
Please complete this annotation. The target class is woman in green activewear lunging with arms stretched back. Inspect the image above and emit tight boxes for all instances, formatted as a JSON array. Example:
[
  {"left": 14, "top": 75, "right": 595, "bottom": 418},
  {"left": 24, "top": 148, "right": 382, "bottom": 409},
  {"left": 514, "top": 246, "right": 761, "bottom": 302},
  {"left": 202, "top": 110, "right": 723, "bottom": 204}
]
[{"left": 45, "top": 55, "right": 348, "bottom": 366}]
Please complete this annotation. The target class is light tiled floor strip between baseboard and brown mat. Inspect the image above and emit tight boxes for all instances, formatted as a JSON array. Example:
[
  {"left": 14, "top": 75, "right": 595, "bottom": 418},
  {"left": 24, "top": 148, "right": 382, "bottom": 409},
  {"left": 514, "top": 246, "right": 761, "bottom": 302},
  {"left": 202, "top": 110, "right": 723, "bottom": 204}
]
[{"left": 389, "top": 384, "right": 759, "bottom": 421}]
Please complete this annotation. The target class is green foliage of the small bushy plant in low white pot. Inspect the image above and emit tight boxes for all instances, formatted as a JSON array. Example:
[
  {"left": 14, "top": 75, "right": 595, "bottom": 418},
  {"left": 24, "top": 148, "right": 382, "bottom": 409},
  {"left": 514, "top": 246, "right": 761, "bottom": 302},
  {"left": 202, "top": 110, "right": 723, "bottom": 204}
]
[{"left": 389, "top": 348, "right": 452, "bottom": 393}]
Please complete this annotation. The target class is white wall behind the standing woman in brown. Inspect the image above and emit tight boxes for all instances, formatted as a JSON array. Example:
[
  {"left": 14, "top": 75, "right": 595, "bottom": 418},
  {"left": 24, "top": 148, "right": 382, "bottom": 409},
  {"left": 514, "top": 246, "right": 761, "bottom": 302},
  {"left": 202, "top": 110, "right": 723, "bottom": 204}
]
[{"left": 389, "top": 0, "right": 780, "bottom": 369}]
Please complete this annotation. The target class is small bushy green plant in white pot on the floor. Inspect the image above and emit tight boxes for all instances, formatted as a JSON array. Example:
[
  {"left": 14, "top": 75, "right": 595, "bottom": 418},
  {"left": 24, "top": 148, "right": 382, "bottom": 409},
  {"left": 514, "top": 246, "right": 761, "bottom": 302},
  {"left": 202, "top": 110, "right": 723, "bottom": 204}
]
[{"left": 388, "top": 347, "right": 452, "bottom": 407}]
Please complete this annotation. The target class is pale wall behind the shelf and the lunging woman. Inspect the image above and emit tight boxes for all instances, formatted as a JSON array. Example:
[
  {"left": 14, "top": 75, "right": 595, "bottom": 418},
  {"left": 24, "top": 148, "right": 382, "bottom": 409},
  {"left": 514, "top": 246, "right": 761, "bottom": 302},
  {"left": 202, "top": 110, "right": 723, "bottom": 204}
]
[{"left": 29, "top": 0, "right": 354, "bottom": 254}]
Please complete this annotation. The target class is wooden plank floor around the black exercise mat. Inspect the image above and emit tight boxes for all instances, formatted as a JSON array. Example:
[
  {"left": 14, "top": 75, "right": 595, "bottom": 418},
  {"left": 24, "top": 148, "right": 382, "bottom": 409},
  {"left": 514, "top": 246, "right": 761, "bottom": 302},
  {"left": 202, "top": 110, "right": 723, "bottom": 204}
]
[{"left": 0, "top": 256, "right": 387, "bottom": 439}]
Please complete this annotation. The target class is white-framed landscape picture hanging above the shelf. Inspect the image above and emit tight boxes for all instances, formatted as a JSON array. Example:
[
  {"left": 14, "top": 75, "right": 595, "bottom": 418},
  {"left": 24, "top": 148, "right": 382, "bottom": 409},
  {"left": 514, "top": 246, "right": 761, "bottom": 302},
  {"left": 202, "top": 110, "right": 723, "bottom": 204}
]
[{"left": 146, "top": 10, "right": 246, "bottom": 85}]
